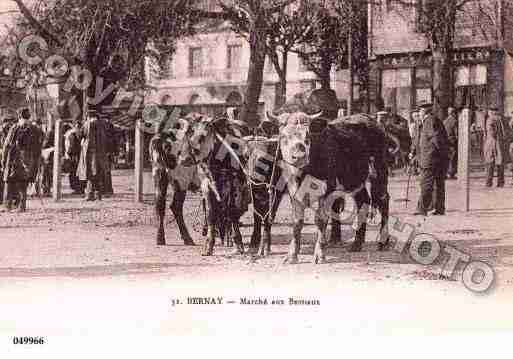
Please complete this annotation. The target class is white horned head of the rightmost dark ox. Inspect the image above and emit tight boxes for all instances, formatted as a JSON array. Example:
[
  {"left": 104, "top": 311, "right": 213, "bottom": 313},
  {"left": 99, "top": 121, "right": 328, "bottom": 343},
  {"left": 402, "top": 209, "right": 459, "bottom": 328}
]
[{"left": 267, "top": 112, "right": 321, "bottom": 168}]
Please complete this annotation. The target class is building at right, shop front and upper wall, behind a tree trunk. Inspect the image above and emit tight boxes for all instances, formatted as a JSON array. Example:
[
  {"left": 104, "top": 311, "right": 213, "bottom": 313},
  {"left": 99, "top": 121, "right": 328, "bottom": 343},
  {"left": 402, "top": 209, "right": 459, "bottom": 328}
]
[{"left": 368, "top": 0, "right": 513, "bottom": 118}]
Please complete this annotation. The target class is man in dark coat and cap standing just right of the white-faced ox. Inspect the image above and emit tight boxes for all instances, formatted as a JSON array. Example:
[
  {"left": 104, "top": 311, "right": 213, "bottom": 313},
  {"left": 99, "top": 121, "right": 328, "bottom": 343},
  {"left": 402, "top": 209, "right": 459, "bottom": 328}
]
[{"left": 415, "top": 104, "right": 449, "bottom": 216}]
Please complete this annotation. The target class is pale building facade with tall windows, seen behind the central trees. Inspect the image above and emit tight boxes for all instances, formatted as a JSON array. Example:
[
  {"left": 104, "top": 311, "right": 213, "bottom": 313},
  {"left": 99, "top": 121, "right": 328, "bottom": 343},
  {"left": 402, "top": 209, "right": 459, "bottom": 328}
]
[{"left": 147, "top": 2, "right": 352, "bottom": 115}]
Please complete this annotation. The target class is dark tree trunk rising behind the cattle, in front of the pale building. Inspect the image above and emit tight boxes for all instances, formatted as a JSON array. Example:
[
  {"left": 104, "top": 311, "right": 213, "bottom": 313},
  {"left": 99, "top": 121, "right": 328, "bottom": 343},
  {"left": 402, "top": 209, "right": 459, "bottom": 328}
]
[{"left": 241, "top": 25, "right": 265, "bottom": 126}]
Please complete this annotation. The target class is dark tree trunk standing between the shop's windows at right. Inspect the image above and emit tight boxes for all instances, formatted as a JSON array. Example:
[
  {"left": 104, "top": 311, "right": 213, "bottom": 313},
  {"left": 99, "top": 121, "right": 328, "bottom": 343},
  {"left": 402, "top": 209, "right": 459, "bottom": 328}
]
[{"left": 433, "top": 48, "right": 452, "bottom": 121}]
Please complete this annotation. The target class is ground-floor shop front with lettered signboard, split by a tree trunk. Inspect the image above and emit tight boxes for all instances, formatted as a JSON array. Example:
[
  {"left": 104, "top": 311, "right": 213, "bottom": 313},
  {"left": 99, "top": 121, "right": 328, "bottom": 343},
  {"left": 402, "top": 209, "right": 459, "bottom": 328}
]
[{"left": 372, "top": 48, "right": 502, "bottom": 118}]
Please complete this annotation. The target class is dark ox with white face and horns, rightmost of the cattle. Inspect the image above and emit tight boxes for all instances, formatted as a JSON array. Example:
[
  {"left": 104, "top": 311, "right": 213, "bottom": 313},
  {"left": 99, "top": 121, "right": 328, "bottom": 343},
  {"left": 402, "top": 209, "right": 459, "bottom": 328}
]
[{"left": 268, "top": 112, "right": 389, "bottom": 263}]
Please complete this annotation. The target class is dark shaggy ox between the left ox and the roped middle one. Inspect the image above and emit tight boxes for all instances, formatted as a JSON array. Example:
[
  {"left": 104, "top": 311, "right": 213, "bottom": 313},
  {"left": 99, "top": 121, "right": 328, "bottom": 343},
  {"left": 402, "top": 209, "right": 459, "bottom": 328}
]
[{"left": 178, "top": 117, "right": 249, "bottom": 256}]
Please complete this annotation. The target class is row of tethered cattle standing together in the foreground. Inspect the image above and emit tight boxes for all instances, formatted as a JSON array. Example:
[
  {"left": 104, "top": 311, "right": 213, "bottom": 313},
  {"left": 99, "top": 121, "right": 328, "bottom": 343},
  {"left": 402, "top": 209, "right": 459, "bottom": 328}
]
[{"left": 149, "top": 107, "right": 398, "bottom": 263}]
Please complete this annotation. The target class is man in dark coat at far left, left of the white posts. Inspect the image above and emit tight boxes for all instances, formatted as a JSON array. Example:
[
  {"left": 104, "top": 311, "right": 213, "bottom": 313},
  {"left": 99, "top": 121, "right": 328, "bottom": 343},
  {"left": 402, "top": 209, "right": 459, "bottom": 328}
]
[{"left": 2, "top": 108, "right": 43, "bottom": 212}]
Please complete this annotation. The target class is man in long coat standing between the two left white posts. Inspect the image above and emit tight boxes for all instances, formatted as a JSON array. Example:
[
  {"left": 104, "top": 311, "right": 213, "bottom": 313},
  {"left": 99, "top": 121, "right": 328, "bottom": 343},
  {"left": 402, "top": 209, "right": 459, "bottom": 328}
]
[{"left": 77, "top": 110, "right": 107, "bottom": 201}]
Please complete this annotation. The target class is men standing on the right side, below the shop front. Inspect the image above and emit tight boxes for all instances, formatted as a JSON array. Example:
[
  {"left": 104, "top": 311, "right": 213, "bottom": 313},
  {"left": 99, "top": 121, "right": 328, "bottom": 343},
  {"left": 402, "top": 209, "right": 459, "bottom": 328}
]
[{"left": 410, "top": 104, "right": 513, "bottom": 216}]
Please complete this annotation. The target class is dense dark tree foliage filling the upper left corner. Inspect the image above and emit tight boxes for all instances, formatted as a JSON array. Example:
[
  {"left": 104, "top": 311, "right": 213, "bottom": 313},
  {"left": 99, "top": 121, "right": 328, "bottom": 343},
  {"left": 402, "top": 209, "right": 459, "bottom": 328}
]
[{"left": 13, "top": 0, "right": 198, "bottom": 116}]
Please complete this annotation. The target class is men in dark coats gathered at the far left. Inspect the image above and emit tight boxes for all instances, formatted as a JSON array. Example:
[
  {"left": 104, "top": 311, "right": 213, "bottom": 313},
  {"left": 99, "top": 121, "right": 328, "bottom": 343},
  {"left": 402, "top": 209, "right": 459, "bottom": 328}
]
[{"left": 0, "top": 108, "right": 117, "bottom": 212}]
